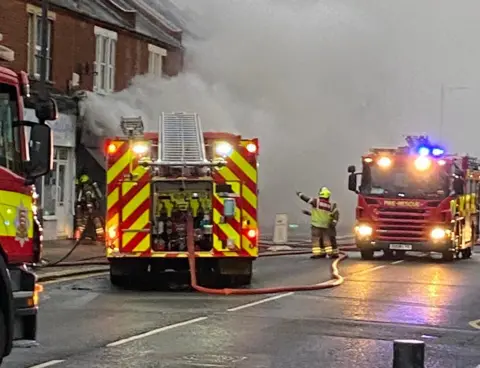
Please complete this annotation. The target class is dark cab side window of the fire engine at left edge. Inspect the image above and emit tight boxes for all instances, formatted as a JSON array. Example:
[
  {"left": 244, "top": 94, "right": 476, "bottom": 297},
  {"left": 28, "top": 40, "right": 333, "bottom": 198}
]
[{"left": 0, "top": 84, "right": 23, "bottom": 175}]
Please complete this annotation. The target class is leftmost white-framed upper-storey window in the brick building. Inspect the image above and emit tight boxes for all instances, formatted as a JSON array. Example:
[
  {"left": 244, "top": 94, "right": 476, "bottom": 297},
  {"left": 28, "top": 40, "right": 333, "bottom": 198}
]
[{"left": 27, "top": 4, "right": 55, "bottom": 81}]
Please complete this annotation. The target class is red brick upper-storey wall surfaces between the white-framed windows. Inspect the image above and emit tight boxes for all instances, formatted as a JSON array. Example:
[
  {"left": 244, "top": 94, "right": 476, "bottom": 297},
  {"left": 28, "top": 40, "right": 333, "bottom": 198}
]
[{"left": 0, "top": 0, "right": 183, "bottom": 91}]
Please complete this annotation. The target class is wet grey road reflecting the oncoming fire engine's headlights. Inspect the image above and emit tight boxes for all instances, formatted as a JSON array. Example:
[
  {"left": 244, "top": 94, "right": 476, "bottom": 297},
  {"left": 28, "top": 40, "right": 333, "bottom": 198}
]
[{"left": 2, "top": 253, "right": 480, "bottom": 368}]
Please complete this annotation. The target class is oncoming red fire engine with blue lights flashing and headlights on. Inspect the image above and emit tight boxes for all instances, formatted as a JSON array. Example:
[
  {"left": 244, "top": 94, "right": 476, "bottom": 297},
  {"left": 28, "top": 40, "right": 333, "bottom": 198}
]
[{"left": 348, "top": 136, "right": 480, "bottom": 261}]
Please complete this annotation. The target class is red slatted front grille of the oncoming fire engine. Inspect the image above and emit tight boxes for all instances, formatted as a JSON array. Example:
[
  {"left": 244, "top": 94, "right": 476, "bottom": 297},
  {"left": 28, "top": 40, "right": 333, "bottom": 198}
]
[{"left": 376, "top": 207, "right": 429, "bottom": 242}]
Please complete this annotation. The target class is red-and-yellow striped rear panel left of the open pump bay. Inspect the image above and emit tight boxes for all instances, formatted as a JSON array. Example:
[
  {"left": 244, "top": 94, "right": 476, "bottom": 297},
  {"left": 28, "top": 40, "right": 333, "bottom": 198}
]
[{"left": 119, "top": 181, "right": 150, "bottom": 253}]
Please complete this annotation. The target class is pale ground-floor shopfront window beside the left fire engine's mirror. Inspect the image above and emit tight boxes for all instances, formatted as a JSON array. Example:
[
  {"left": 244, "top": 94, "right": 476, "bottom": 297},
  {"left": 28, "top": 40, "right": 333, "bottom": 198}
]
[{"left": 42, "top": 147, "right": 68, "bottom": 216}]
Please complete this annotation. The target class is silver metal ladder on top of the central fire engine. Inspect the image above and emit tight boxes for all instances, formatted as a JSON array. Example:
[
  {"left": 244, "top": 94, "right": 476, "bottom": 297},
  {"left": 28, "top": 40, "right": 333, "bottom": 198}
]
[{"left": 158, "top": 112, "right": 208, "bottom": 166}]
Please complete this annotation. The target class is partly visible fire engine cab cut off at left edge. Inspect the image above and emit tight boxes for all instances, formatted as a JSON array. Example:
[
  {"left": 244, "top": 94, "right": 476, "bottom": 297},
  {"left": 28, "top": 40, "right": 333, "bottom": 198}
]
[{"left": 0, "top": 34, "right": 57, "bottom": 363}]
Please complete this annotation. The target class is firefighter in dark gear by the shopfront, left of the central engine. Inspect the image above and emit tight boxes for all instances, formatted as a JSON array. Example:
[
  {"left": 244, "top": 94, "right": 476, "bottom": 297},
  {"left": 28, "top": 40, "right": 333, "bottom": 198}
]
[{"left": 75, "top": 169, "right": 105, "bottom": 240}]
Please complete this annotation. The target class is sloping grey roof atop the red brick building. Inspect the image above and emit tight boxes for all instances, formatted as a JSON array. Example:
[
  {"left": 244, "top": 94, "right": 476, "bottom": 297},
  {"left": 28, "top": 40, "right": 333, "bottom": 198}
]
[{"left": 50, "top": 0, "right": 183, "bottom": 49}]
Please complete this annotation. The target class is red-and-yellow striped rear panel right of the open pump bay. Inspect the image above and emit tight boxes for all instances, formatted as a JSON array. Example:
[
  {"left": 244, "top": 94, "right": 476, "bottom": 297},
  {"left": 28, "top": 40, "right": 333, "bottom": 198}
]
[{"left": 213, "top": 181, "right": 242, "bottom": 252}]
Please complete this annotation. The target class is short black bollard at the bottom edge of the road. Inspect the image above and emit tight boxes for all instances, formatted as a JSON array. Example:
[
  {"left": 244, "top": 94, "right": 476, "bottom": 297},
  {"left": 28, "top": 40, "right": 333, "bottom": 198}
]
[{"left": 393, "top": 340, "right": 425, "bottom": 368}]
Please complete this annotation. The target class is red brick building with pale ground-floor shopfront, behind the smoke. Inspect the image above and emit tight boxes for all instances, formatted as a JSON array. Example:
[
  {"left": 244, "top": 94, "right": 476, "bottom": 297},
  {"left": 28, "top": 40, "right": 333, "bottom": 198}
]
[{"left": 0, "top": 0, "right": 184, "bottom": 239}]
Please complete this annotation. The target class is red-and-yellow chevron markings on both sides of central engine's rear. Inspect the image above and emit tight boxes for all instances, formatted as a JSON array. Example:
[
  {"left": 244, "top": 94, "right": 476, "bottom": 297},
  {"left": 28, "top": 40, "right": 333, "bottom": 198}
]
[{"left": 106, "top": 134, "right": 258, "bottom": 258}]
